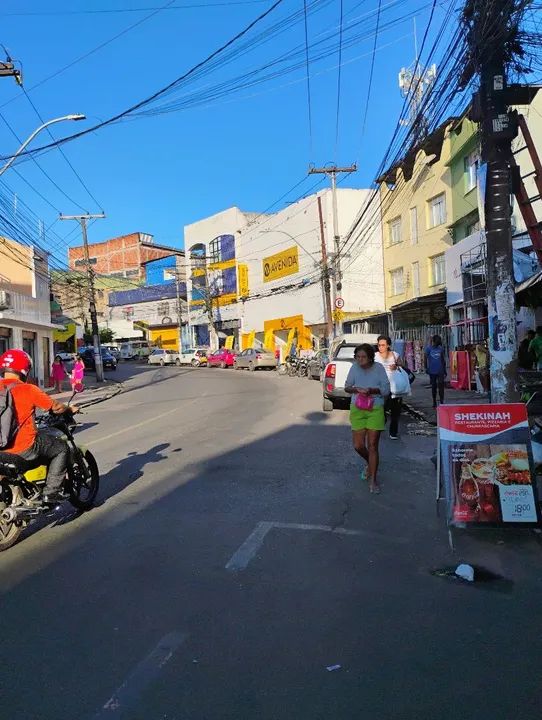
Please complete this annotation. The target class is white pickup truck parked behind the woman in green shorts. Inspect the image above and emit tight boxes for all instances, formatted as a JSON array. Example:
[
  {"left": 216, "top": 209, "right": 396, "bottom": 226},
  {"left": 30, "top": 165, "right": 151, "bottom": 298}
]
[{"left": 322, "top": 333, "right": 378, "bottom": 412}]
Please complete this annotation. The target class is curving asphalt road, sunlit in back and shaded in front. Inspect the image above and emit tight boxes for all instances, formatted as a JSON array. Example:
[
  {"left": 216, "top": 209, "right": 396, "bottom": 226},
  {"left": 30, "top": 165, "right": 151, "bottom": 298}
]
[{"left": 0, "top": 366, "right": 542, "bottom": 720}]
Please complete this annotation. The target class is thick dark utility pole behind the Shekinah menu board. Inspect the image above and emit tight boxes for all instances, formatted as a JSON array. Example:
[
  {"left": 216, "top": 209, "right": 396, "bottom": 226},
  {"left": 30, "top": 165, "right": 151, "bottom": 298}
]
[{"left": 463, "top": 0, "right": 519, "bottom": 403}]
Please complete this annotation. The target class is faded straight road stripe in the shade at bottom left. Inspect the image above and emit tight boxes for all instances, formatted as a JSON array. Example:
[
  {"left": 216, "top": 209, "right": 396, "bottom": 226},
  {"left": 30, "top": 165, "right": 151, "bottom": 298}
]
[{"left": 93, "top": 632, "right": 188, "bottom": 720}]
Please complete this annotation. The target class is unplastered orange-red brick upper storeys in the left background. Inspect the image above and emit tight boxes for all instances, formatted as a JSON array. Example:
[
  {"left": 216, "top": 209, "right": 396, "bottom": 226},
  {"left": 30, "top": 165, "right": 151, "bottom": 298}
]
[{"left": 68, "top": 232, "right": 181, "bottom": 280}]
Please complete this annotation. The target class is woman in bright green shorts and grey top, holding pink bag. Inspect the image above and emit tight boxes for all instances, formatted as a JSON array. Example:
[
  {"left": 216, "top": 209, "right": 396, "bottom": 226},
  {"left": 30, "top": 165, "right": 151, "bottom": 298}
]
[{"left": 344, "top": 343, "right": 390, "bottom": 493}]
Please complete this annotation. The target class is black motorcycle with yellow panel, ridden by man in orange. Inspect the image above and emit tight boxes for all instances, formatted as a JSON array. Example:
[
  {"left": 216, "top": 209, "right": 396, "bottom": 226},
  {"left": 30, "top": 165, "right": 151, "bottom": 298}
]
[{"left": 0, "top": 394, "right": 100, "bottom": 552}]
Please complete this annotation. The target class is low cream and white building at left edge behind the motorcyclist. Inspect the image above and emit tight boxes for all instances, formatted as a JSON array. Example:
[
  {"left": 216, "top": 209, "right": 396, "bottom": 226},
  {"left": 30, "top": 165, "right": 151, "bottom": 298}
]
[{"left": 0, "top": 238, "right": 59, "bottom": 387}]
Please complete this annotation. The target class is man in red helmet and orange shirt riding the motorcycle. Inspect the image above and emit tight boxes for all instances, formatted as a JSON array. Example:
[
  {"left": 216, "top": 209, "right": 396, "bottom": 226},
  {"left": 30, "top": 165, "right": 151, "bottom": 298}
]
[{"left": 0, "top": 349, "right": 79, "bottom": 505}]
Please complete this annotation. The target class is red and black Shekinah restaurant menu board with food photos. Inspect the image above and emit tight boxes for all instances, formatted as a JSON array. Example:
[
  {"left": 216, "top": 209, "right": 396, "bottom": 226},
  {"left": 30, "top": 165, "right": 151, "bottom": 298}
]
[{"left": 438, "top": 403, "right": 540, "bottom": 527}]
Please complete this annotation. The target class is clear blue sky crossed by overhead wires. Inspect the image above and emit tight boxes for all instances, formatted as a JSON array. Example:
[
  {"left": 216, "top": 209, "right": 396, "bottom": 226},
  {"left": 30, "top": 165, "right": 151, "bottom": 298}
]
[{"left": 0, "top": 0, "right": 452, "bottom": 257}]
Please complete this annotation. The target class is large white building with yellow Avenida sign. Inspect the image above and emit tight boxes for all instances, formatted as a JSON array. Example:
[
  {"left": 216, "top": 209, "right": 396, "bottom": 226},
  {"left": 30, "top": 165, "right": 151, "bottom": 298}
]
[{"left": 236, "top": 189, "right": 384, "bottom": 349}]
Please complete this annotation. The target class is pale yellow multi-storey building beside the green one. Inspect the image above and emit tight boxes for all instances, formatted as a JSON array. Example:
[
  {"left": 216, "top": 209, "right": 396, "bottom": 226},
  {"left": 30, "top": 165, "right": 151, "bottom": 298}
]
[{"left": 379, "top": 119, "right": 453, "bottom": 330}]
